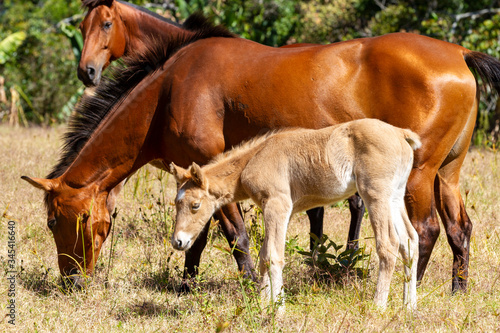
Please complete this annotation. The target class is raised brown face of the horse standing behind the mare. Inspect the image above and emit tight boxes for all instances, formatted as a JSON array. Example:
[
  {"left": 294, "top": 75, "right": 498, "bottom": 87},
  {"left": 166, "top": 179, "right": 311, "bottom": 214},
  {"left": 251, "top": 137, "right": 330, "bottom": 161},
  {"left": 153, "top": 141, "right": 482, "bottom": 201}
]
[{"left": 78, "top": 1, "right": 126, "bottom": 86}]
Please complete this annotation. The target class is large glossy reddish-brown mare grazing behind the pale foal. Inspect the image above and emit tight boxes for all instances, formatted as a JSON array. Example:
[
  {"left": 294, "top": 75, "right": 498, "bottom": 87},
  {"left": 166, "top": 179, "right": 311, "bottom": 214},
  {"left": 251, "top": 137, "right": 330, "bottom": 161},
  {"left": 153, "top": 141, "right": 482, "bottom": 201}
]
[{"left": 25, "top": 10, "right": 500, "bottom": 290}]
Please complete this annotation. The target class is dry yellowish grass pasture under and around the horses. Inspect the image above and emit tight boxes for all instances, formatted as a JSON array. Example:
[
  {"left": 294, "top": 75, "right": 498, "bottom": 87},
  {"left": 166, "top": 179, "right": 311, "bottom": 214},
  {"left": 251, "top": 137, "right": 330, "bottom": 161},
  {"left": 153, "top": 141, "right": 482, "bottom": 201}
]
[{"left": 0, "top": 126, "right": 500, "bottom": 332}]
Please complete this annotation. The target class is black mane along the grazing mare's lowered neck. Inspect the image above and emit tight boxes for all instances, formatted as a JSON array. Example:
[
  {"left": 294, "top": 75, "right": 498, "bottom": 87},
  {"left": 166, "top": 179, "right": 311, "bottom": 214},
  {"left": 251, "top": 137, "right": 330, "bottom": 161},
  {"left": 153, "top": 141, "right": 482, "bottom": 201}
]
[{"left": 46, "top": 14, "right": 235, "bottom": 200}]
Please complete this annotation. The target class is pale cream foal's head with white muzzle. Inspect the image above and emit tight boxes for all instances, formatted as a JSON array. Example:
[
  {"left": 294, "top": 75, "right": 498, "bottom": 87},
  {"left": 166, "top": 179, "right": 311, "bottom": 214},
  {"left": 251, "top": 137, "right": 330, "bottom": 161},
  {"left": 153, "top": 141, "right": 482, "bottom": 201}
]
[{"left": 170, "top": 163, "right": 220, "bottom": 251}]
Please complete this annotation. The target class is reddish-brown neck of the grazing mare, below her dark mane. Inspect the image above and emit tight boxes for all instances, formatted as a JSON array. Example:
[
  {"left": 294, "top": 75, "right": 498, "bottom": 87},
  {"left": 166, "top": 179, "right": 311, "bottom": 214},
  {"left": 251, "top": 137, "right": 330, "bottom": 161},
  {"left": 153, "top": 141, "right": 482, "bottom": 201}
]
[{"left": 61, "top": 70, "right": 164, "bottom": 192}]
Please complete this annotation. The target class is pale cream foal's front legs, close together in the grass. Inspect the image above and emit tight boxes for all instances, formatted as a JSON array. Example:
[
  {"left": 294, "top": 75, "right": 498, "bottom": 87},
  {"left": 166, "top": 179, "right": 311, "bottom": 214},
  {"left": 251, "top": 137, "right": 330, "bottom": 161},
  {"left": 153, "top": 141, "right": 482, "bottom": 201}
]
[{"left": 259, "top": 198, "right": 293, "bottom": 302}]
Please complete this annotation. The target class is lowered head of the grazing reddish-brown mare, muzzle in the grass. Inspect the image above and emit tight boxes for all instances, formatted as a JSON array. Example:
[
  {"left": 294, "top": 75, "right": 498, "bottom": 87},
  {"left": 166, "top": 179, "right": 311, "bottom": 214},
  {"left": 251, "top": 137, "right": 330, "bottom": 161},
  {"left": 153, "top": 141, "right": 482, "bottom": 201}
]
[{"left": 23, "top": 177, "right": 111, "bottom": 287}]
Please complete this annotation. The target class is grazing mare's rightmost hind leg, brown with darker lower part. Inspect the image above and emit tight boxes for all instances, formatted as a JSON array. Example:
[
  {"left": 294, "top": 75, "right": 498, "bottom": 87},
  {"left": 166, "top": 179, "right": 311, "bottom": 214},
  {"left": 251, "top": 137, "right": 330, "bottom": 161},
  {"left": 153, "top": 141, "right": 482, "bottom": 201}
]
[{"left": 434, "top": 154, "right": 472, "bottom": 292}]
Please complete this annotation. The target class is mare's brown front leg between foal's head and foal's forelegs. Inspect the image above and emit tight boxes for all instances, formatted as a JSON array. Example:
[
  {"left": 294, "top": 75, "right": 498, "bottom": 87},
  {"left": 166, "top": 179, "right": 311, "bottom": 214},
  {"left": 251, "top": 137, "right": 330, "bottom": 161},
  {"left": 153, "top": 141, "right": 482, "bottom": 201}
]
[{"left": 216, "top": 203, "right": 257, "bottom": 281}]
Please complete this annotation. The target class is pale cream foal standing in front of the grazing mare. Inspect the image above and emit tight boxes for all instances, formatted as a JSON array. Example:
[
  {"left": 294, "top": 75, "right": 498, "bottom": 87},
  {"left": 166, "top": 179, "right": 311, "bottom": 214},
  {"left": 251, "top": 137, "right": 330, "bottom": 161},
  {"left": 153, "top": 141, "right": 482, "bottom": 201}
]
[{"left": 171, "top": 119, "right": 421, "bottom": 309}]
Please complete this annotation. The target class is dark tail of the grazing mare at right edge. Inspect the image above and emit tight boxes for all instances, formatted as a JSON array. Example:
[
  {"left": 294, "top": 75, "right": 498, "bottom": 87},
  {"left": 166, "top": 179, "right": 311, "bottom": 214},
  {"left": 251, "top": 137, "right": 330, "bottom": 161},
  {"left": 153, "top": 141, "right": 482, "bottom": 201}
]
[{"left": 464, "top": 51, "right": 500, "bottom": 94}]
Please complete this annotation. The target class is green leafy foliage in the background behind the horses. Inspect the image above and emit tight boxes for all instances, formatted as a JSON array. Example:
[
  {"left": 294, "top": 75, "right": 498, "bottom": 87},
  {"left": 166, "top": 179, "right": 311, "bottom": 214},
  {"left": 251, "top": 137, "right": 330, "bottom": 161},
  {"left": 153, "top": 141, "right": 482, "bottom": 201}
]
[{"left": 0, "top": 0, "right": 500, "bottom": 143}]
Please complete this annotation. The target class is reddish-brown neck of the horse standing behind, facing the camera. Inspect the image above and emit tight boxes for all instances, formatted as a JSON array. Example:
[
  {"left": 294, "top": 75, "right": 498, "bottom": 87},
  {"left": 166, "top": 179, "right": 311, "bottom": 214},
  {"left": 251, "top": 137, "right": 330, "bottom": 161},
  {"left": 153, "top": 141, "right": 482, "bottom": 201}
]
[{"left": 120, "top": 4, "right": 193, "bottom": 55}]
